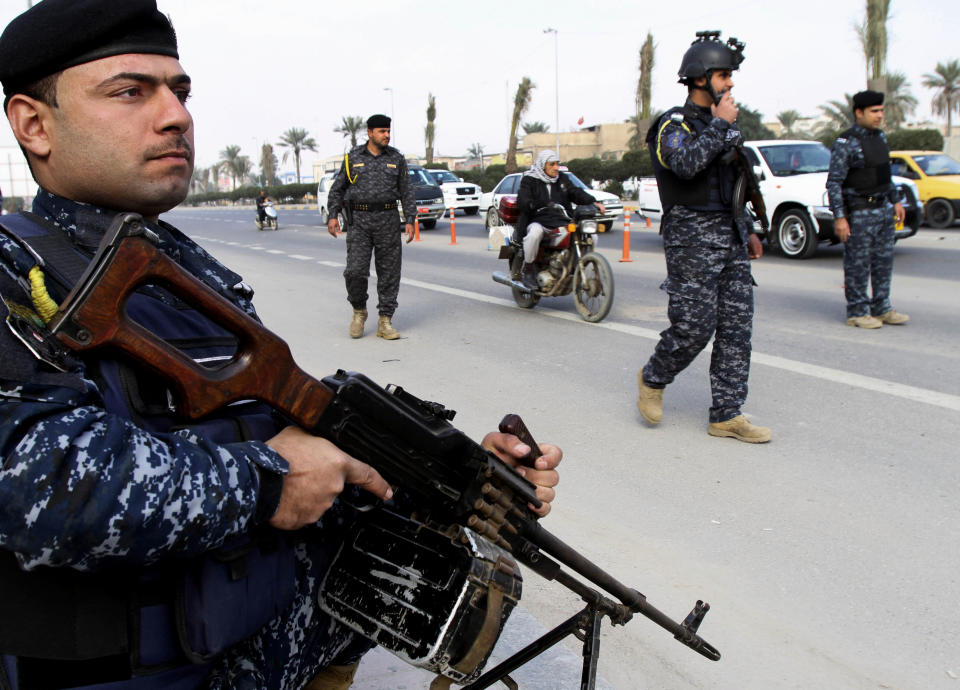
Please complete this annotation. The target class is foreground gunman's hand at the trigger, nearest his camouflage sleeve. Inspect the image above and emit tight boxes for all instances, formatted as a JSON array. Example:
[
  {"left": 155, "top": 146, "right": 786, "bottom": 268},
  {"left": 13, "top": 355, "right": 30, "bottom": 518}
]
[{"left": 267, "top": 426, "right": 393, "bottom": 530}]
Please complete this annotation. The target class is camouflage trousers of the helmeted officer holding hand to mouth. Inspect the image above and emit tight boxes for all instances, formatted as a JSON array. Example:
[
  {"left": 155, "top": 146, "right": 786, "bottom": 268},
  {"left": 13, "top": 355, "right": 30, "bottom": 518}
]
[{"left": 643, "top": 245, "right": 753, "bottom": 422}]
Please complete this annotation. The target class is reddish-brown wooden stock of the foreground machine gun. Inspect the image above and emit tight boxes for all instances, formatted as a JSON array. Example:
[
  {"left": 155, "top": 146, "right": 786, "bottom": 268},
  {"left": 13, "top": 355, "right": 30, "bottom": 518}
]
[{"left": 51, "top": 237, "right": 333, "bottom": 422}]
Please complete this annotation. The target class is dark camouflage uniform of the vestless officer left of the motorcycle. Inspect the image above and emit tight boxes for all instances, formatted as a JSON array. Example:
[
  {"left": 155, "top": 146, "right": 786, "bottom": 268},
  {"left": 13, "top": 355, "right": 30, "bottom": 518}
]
[{"left": 327, "top": 144, "right": 417, "bottom": 316}]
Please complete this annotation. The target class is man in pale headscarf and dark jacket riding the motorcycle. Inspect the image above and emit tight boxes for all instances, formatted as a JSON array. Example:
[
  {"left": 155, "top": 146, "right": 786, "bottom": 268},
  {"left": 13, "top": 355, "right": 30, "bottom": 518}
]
[{"left": 517, "top": 149, "right": 606, "bottom": 290}]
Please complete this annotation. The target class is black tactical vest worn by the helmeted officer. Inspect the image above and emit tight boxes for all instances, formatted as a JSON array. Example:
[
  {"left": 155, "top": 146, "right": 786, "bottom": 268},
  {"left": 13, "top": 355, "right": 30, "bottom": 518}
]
[{"left": 646, "top": 106, "right": 736, "bottom": 215}]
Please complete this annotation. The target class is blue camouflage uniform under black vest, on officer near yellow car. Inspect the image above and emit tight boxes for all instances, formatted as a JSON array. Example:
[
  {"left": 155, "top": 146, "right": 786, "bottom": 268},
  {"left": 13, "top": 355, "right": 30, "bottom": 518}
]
[{"left": 827, "top": 125, "right": 901, "bottom": 318}]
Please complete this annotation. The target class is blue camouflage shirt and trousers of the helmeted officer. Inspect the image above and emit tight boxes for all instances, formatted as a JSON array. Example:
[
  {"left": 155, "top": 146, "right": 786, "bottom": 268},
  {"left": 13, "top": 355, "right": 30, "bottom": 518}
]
[{"left": 643, "top": 99, "right": 753, "bottom": 422}]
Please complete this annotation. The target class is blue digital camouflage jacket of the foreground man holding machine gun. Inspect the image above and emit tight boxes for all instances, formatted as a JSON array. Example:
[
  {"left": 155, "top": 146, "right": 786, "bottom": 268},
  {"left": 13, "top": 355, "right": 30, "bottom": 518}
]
[{"left": 0, "top": 189, "right": 288, "bottom": 570}]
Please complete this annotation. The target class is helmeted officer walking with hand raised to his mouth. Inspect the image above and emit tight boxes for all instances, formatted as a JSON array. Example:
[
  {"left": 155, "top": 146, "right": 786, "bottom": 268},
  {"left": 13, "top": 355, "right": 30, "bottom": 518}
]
[{"left": 637, "top": 31, "right": 770, "bottom": 443}]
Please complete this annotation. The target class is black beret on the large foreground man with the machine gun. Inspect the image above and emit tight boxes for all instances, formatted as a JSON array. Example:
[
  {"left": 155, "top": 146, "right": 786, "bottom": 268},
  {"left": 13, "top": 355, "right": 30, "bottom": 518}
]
[{"left": 0, "top": 0, "right": 180, "bottom": 96}]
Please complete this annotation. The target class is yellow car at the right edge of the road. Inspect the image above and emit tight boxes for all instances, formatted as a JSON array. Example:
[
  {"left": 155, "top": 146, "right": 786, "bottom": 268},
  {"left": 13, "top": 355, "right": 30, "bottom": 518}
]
[{"left": 890, "top": 151, "right": 960, "bottom": 228}]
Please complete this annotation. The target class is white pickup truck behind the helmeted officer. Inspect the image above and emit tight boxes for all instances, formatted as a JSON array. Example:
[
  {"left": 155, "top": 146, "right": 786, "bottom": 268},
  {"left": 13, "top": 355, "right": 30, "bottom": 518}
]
[{"left": 639, "top": 139, "right": 923, "bottom": 259}]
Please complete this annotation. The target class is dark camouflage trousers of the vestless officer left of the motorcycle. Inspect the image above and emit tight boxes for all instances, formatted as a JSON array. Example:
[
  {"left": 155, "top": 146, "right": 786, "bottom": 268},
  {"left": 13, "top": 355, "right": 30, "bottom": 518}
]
[{"left": 343, "top": 211, "right": 403, "bottom": 316}]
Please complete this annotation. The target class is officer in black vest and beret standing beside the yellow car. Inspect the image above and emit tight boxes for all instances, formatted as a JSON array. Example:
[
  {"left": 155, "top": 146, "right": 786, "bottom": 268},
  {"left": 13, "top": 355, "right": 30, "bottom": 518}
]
[{"left": 827, "top": 91, "right": 910, "bottom": 328}]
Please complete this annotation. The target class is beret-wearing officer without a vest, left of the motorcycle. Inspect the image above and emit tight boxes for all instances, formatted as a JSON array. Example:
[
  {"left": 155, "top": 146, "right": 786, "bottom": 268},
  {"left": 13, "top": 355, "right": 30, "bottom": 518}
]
[{"left": 327, "top": 115, "right": 417, "bottom": 340}]
